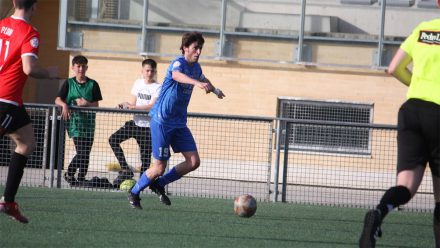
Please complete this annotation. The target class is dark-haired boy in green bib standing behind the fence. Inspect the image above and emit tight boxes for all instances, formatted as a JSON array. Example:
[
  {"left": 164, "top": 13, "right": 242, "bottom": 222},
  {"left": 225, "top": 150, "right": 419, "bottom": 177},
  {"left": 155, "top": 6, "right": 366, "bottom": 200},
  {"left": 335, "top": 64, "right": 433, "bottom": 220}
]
[{"left": 55, "top": 55, "right": 102, "bottom": 186}]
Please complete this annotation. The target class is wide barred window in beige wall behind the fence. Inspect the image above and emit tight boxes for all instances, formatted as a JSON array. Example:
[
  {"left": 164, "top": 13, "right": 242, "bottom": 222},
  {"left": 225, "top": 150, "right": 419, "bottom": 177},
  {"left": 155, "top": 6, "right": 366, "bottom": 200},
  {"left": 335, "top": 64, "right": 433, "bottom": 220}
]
[{"left": 277, "top": 98, "right": 373, "bottom": 155}]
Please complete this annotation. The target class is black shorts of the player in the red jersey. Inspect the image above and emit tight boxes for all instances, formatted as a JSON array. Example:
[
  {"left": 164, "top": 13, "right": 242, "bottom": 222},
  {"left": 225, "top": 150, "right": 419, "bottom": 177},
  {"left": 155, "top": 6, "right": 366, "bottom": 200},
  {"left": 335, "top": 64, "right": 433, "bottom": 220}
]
[{"left": 0, "top": 102, "right": 31, "bottom": 138}]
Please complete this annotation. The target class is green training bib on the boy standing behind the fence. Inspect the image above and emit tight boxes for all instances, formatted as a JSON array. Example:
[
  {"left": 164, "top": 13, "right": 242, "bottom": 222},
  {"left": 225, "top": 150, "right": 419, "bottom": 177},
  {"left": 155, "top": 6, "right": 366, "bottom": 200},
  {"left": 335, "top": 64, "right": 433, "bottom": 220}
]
[{"left": 65, "top": 78, "right": 101, "bottom": 138}]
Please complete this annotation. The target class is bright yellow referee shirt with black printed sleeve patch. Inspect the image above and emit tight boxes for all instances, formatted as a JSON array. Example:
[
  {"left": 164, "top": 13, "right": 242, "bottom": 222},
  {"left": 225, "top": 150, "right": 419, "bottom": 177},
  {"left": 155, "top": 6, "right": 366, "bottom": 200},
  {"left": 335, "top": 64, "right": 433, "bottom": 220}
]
[{"left": 400, "top": 19, "right": 440, "bottom": 105}]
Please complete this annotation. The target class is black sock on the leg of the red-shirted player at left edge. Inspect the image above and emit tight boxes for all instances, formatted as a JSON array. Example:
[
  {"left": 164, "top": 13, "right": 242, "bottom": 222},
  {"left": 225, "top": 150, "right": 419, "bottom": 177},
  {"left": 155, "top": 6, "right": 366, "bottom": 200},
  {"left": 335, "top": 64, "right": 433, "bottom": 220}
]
[{"left": 4, "top": 152, "right": 28, "bottom": 202}]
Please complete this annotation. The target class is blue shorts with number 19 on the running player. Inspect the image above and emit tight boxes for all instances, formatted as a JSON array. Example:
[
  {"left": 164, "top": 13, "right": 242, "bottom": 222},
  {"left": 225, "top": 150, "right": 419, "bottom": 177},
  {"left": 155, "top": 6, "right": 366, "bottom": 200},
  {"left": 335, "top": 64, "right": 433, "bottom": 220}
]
[{"left": 150, "top": 120, "right": 197, "bottom": 161}]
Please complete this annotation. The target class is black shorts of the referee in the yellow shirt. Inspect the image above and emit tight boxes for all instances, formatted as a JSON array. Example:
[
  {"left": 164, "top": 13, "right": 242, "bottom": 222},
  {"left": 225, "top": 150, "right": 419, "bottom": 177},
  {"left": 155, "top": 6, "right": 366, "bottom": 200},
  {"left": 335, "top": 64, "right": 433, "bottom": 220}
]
[{"left": 397, "top": 99, "right": 440, "bottom": 176}]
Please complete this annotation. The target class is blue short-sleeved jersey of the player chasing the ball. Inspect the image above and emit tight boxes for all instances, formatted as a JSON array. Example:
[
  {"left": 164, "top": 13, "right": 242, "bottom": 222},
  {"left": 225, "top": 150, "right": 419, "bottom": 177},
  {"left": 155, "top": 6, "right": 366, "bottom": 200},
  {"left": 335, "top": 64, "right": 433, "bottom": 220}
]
[{"left": 150, "top": 56, "right": 205, "bottom": 127}]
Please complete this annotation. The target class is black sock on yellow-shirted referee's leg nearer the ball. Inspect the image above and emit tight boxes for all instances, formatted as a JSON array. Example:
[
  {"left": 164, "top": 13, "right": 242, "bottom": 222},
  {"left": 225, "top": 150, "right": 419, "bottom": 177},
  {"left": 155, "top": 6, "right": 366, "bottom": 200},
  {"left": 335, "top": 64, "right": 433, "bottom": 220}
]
[{"left": 376, "top": 186, "right": 411, "bottom": 219}]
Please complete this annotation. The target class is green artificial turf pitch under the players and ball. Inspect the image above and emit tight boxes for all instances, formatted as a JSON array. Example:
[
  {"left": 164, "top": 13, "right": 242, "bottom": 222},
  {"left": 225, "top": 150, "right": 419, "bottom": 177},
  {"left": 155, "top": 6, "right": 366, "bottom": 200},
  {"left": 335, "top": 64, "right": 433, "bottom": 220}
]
[{"left": 0, "top": 187, "right": 434, "bottom": 248}]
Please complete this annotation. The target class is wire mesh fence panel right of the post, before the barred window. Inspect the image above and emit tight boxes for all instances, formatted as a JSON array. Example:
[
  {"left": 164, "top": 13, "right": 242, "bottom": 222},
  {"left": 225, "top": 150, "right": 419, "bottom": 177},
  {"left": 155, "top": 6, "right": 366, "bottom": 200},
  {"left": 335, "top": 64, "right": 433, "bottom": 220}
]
[{"left": 280, "top": 120, "right": 435, "bottom": 211}]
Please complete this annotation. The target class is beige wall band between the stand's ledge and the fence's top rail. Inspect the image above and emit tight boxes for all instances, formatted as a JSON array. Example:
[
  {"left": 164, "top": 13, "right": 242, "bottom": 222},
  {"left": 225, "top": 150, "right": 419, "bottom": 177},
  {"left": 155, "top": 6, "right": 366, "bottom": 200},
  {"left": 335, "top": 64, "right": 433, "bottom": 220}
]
[{"left": 80, "top": 54, "right": 406, "bottom": 124}]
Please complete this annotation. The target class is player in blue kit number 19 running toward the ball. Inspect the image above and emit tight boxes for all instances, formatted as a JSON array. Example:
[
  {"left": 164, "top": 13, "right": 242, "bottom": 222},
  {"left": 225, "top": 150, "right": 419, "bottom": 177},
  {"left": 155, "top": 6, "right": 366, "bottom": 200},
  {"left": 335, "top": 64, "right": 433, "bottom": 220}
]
[{"left": 128, "top": 32, "right": 225, "bottom": 209}]
